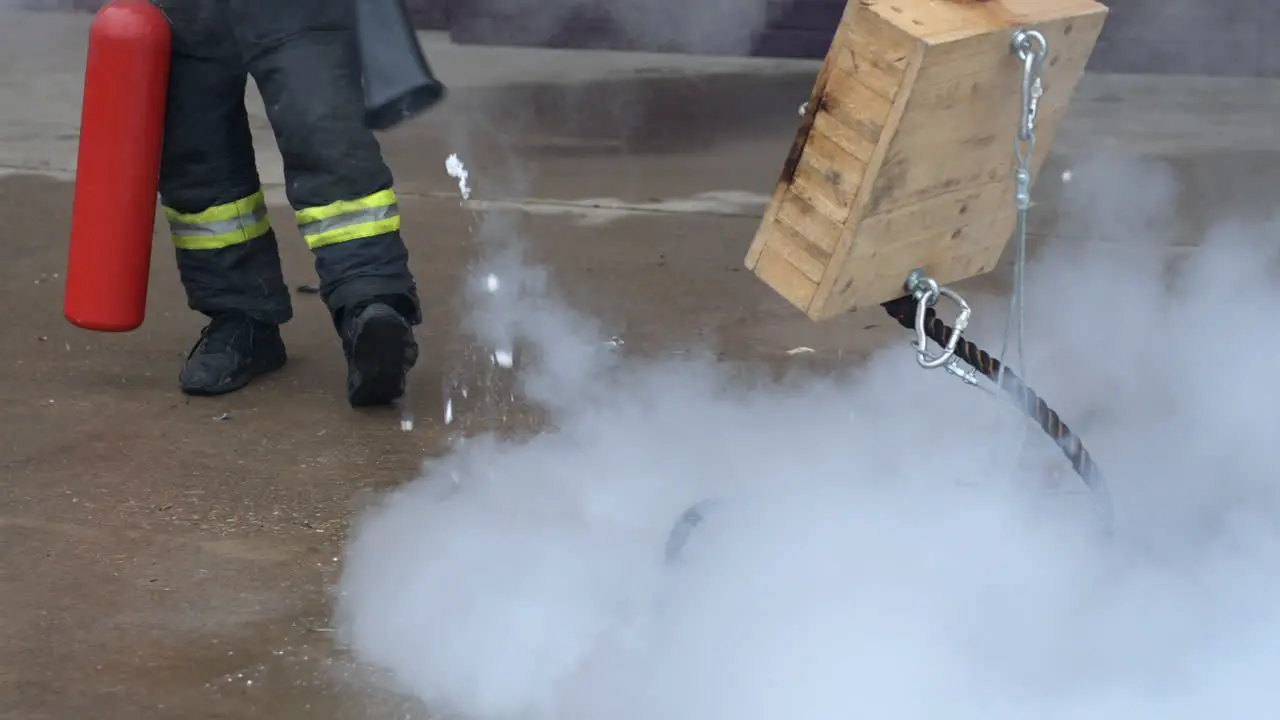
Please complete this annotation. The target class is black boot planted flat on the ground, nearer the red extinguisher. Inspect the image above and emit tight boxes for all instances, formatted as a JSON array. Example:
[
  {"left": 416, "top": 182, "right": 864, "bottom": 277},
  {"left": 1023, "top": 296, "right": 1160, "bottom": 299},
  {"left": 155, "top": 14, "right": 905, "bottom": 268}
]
[{"left": 178, "top": 313, "right": 288, "bottom": 395}]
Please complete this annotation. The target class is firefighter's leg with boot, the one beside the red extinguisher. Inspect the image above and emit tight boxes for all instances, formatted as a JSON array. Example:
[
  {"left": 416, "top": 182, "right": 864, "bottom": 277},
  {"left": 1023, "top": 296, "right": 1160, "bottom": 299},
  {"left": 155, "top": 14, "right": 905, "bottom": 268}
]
[{"left": 160, "top": 9, "right": 292, "bottom": 395}]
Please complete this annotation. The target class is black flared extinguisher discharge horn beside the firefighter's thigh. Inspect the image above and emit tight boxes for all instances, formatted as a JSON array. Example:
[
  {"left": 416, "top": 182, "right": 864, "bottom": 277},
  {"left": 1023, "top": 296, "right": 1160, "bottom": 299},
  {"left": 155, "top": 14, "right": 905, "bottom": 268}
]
[{"left": 355, "top": 0, "right": 444, "bottom": 131}]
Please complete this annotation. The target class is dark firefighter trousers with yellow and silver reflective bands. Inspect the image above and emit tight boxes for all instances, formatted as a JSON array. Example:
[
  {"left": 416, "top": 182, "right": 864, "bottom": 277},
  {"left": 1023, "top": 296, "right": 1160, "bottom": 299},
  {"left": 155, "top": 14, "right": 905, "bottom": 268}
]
[{"left": 157, "top": 0, "right": 420, "bottom": 323}]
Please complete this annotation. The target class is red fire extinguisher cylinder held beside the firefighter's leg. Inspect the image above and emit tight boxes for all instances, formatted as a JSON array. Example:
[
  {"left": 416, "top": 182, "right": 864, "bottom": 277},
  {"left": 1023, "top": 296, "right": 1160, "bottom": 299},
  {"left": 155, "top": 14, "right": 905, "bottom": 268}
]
[{"left": 63, "top": 0, "right": 172, "bottom": 332}]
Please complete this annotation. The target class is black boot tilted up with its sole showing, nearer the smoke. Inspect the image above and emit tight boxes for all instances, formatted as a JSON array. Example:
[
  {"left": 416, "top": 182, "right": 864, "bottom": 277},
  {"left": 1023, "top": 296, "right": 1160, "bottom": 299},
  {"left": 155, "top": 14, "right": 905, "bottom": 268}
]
[{"left": 342, "top": 302, "right": 417, "bottom": 407}]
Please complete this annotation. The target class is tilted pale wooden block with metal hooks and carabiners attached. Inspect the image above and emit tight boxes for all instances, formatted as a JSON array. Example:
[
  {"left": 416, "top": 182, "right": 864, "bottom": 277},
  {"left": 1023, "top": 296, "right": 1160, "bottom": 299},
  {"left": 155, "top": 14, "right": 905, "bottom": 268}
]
[{"left": 746, "top": 0, "right": 1107, "bottom": 320}]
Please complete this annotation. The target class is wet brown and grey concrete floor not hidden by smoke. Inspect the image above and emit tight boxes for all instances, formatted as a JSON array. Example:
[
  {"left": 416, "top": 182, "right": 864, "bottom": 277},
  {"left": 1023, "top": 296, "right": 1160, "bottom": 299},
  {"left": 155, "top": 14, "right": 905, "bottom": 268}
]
[{"left": 0, "top": 7, "right": 1280, "bottom": 720}]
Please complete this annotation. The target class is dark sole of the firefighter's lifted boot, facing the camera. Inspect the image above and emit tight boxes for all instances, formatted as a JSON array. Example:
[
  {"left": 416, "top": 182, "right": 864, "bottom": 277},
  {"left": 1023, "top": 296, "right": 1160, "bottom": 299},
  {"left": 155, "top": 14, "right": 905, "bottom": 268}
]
[{"left": 347, "top": 309, "right": 417, "bottom": 407}]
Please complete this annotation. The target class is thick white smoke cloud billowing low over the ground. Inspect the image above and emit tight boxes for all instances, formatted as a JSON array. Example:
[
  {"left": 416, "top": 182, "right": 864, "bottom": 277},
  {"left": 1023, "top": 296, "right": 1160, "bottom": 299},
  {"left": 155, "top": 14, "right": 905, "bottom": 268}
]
[{"left": 338, "top": 147, "right": 1280, "bottom": 720}]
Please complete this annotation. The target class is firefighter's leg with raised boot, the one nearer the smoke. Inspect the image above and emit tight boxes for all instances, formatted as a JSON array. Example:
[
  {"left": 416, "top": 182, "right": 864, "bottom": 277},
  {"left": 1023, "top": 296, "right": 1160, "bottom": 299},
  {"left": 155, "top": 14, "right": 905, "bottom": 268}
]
[{"left": 232, "top": 0, "right": 421, "bottom": 406}]
